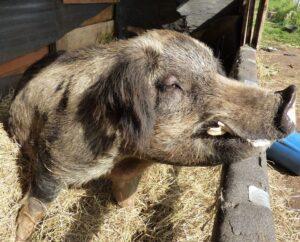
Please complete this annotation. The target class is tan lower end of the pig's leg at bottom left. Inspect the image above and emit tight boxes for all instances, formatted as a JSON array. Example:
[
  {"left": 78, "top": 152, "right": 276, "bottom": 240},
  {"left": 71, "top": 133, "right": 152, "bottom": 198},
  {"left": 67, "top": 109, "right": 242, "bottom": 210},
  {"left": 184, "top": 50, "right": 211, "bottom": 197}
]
[{"left": 15, "top": 198, "right": 45, "bottom": 242}]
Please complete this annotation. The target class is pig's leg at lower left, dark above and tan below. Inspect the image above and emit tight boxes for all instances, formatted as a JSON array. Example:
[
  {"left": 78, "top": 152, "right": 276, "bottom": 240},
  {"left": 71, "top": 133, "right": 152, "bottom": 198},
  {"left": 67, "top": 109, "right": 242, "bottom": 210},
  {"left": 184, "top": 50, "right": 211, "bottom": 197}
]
[{"left": 16, "top": 164, "right": 60, "bottom": 242}]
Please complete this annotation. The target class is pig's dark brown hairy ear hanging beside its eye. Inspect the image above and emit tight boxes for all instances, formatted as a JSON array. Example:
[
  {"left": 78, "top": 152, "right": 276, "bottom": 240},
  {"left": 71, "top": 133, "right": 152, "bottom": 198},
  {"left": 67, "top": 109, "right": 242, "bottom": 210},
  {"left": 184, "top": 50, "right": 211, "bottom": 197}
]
[{"left": 103, "top": 60, "right": 154, "bottom": 148}]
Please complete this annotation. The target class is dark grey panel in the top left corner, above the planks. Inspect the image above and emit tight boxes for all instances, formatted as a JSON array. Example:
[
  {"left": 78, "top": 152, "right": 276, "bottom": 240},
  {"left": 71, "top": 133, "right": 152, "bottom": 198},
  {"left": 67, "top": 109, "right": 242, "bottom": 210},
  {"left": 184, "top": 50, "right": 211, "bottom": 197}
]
[{"left": 0, "top": 0, "right": 108, "bottom": 63}]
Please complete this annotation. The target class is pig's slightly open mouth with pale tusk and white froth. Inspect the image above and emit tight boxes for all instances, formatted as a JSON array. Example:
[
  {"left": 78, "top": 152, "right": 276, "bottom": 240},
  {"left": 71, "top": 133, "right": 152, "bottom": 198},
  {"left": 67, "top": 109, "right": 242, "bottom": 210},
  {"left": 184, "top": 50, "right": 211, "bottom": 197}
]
[{"left": 194, "top": 121, "right": 271, "bottom": 148}]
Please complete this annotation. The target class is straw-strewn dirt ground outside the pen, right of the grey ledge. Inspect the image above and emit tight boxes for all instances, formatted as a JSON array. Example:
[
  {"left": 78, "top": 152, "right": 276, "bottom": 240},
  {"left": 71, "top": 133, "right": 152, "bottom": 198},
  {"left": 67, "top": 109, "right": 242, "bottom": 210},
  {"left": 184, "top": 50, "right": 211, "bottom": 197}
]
[{"left": 258, "top": 45, "right": 300, "bottom": 241}]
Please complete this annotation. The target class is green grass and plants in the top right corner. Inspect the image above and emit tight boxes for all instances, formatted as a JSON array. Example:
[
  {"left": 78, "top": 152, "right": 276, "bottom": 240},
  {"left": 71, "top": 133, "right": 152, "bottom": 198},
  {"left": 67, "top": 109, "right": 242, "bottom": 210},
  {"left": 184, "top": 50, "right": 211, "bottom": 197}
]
[{"left": 263, "top": 0, "right": 300, "bottom": 47}]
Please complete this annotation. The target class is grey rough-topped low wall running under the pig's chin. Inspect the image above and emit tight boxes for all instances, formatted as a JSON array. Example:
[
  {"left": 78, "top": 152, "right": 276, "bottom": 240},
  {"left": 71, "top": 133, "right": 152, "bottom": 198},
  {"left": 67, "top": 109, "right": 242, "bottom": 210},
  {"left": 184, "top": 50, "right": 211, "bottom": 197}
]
[{"left": 212, "top": 46, "right": 276, "bottom": 242}]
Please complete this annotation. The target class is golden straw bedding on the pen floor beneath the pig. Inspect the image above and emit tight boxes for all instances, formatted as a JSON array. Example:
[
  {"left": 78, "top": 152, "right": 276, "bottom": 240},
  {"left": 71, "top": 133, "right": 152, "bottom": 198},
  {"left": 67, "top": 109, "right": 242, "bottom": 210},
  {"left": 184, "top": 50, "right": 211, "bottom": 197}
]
[{"left": 0, "top": 92, "right": 221, "bottom": 241}]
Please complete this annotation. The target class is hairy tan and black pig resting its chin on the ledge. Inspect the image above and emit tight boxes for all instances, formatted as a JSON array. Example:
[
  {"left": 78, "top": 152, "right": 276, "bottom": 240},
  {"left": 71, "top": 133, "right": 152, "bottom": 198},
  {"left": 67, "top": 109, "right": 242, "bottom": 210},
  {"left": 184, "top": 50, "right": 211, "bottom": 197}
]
[{"left": 9, "top": 30, "right": 295, "bottom": 241}]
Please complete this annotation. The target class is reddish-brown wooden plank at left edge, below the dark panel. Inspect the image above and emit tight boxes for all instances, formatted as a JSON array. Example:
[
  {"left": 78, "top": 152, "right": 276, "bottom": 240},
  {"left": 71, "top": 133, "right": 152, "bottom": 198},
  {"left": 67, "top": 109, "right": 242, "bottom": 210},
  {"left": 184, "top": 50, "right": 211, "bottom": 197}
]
[{"left": 0, "top": 47, "right": 49, "bottom": 77}]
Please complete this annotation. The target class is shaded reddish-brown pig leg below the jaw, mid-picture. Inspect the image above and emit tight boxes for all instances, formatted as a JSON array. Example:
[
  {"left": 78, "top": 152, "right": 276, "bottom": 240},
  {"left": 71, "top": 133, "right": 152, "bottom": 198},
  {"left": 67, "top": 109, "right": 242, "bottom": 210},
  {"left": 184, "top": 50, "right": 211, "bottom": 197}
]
[{"left": 110, "top": 158, "right": 152, "bottom": 207}]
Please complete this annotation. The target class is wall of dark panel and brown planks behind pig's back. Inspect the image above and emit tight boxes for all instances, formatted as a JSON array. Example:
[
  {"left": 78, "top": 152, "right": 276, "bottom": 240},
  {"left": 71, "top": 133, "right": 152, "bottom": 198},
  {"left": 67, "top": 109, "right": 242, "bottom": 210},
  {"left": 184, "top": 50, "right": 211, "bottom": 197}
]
[{"left": 0, "top": 0, "right": 117, "bottom": 98}]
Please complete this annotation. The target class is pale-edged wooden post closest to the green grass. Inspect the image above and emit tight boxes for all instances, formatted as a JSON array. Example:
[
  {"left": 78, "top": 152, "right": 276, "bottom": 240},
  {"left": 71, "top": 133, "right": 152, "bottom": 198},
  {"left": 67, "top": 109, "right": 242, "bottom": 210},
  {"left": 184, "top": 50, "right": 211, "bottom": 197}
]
[{"left": 251, "top": 0, "right": 269, "bottom": 49}]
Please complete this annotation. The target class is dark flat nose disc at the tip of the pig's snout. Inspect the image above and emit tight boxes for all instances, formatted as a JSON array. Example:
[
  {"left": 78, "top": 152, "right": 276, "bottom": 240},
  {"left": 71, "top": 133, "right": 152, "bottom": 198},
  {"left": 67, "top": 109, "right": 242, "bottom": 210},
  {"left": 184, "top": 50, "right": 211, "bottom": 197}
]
[{"left": 275, "top": 85, "right": 296, "bottom": 134}]
